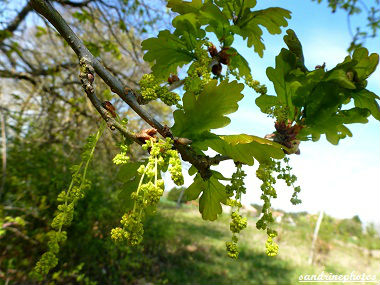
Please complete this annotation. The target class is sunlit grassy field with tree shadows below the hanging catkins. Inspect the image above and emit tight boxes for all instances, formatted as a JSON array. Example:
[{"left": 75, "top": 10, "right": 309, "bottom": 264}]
[{"left": 148, "top": 201, "right": 380, "bottom": 285}]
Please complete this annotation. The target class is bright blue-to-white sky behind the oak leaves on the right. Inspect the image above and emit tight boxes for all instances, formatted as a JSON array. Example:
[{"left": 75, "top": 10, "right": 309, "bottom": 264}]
[{"left": 168, "top": 0, "right": 380, "bottom": 223}]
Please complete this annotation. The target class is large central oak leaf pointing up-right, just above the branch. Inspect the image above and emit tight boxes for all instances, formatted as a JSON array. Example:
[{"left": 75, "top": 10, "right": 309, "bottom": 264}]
[{"left": 171, "top": 80, "right": 244, "bottom": 139}]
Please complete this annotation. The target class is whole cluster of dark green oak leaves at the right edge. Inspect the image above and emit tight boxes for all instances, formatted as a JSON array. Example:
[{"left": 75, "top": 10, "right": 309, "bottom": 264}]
[{"left": 266, "top": 36, "right": 380, "bottom": 144}]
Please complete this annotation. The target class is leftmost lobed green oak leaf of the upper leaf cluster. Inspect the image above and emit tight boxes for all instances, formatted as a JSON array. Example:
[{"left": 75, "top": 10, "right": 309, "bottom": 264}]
[{"left": 141, "top": 30, "right": 193, "bottom": 79}]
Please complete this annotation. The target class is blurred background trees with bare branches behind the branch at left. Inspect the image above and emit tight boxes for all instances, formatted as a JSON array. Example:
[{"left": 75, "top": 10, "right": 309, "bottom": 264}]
[{"left": 0, "top": 1, "right": 174, "bottom": 282}]
